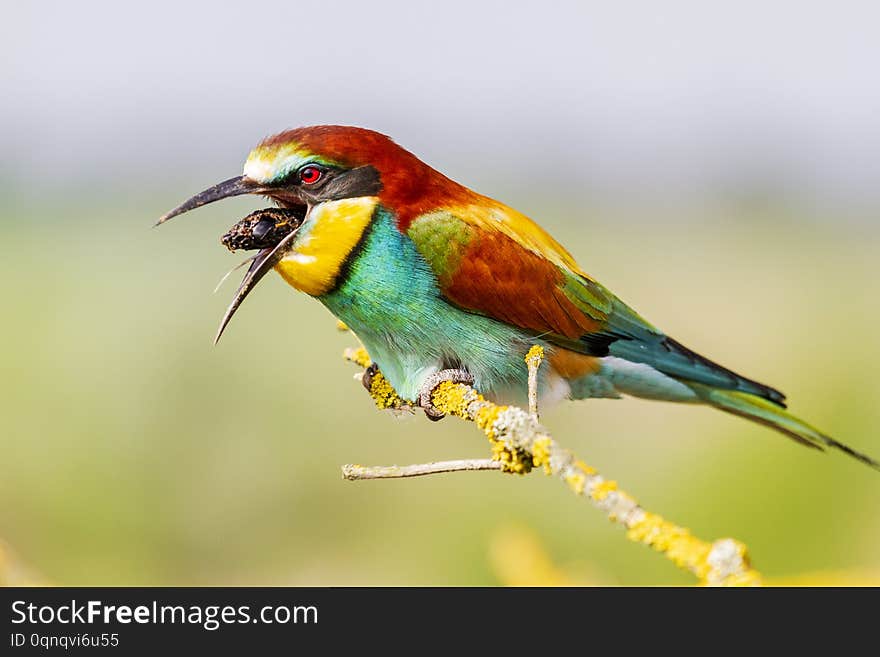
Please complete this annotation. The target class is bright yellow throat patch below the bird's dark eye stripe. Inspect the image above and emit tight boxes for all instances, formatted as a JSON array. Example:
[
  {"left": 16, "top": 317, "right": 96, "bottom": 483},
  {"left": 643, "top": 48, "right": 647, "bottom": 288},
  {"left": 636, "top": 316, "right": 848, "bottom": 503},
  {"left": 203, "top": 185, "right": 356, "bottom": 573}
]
[{"left": 275, "top": 196, "right": 379, "bottom": 297}]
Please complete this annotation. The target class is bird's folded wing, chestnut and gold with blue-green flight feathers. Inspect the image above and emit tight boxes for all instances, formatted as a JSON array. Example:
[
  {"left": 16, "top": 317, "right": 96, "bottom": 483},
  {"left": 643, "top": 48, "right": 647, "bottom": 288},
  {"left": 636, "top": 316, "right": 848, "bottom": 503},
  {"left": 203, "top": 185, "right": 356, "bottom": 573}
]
[{"left": 407, "top": 199, "right": 784, "bottom": 402}]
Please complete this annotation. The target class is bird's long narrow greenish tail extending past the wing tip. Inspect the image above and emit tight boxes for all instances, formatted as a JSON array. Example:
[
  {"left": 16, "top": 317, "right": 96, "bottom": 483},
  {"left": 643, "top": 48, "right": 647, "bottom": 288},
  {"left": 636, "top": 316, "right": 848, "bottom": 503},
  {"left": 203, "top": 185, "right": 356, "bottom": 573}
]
[{"left": 686, "top": 381, "right": 880, "bottom": 470}]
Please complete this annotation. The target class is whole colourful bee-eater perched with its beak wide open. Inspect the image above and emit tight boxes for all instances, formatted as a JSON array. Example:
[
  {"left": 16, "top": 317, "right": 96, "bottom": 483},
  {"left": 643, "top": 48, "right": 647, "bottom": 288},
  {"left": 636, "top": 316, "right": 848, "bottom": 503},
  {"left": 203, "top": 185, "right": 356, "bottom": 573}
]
[{"left": 159, "top": 126, "right": 880, "bottom": 469}]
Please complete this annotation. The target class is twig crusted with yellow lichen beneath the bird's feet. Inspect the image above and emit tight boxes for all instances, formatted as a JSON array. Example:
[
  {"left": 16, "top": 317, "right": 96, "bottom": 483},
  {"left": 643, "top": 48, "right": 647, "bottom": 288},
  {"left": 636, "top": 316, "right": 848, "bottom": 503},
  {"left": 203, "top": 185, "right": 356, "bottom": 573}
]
[{"left": 346, "top": 347, "right": 761, "bottom": 586}]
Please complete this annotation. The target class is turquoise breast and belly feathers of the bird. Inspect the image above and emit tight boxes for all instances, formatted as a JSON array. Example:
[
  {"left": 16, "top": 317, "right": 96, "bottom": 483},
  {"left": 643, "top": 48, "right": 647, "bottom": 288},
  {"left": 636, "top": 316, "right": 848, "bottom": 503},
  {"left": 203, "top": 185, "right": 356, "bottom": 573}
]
[{"left": 320, "top": 207, "right": 535, "bottom": 399}]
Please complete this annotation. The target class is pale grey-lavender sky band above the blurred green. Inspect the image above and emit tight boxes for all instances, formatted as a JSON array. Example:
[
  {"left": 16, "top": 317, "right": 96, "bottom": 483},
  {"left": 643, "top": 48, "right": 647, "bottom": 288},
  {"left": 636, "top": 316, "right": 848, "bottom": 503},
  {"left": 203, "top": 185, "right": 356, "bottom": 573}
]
[{"left": 0, "top": 0, "right": 880, "bottom": 208}]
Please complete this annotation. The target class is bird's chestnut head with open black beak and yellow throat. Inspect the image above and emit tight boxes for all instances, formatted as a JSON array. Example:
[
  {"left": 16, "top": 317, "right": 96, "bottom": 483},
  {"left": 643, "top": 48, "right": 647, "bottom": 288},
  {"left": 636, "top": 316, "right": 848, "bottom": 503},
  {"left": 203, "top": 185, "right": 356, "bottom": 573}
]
[{"left": 157, "top": 126, "right": 473, "bottom": 339}]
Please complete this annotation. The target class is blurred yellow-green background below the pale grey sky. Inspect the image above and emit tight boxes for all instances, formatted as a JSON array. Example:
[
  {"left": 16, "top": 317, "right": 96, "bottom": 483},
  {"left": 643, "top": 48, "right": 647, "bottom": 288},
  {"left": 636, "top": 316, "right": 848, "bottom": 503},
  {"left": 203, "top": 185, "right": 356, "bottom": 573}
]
[{"left": 0, "top": 195, "right": 880, "bottom": 584}]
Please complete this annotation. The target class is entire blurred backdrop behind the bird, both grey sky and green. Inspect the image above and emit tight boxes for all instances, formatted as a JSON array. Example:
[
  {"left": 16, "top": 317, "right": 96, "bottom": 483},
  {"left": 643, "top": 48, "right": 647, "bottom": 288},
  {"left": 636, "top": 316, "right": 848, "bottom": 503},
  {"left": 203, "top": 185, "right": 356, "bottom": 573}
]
[{"left": 0, "top": 3, "right": 880, "bottom": 585}]
